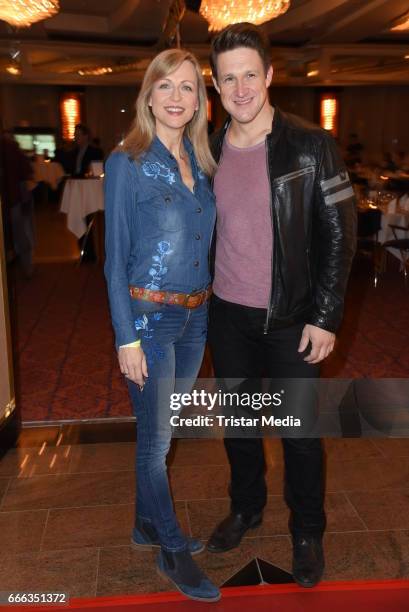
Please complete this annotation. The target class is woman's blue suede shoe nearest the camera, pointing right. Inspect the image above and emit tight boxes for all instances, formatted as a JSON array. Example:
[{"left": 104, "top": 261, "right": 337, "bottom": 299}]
[{"left": 156, "top": 548, "right": 221, "bottom": 602}]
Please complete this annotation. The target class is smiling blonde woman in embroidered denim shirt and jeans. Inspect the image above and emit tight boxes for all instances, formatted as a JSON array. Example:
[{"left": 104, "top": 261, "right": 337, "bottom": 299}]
[{"left": 105, "top": 49, "right": 220, "bottom": 601}]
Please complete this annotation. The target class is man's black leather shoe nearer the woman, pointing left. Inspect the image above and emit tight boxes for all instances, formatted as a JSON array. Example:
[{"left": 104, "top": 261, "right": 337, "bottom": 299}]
[{"left": 207, "top": 512, "right": 263, "bottom": 552}]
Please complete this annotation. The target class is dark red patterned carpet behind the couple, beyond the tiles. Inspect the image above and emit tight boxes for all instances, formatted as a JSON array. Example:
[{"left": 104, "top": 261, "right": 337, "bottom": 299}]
[{"left": 11, "top": 261, "right": 409, "bottom": 421}]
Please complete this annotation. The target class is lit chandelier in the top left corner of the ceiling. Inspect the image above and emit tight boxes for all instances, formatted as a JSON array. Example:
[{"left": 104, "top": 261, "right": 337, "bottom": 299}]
[{"left": 0, "top": 0, "right": 60, "bottom": 28}]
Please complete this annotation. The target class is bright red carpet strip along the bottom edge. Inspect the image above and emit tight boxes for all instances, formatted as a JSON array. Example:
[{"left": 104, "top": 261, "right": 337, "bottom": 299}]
[{"left": 7, "top": 580, "right": 409, "bottom": 612}]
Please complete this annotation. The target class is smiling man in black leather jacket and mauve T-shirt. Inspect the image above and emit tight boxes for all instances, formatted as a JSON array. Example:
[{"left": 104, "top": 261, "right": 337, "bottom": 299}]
[{"left": 208, "top": 23, "right": 355, "bottom": 587}]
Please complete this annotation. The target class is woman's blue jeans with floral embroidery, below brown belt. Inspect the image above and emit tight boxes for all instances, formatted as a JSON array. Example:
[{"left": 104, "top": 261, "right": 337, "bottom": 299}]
[{"left": 128, "top": 300, "right": 207, "bottom": 551}]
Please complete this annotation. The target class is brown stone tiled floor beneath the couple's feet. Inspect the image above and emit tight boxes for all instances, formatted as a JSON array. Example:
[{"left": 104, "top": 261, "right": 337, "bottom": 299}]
[{"left": 0, "top": 430, "right": 409, "bottom": 597}]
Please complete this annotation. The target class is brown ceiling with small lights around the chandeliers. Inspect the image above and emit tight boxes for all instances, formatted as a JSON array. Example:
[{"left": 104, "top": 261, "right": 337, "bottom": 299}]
[{"left": 0, "top": 0, "right": 409, "bottom": 86}]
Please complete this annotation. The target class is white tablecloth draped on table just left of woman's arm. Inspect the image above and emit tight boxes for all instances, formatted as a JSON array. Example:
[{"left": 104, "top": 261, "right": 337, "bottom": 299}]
[{"left": 60, "top": 179, "right": 104, "bottom": 238}]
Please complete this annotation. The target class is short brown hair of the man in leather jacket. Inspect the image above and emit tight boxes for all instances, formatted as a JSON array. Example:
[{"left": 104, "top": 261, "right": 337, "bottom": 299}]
[{"left": 210, "top": 22, "right": 271, "bottom": 81}]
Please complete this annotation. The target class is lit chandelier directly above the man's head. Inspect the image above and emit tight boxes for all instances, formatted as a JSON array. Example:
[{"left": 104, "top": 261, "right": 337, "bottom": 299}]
[{"left": 200, "top": 0, "right": 290, "bottom": 31}]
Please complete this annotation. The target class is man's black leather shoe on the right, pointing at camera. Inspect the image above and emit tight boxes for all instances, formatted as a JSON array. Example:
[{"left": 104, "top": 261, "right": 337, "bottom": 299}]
[{"left": 293, "top": 536, "right": 325, "bottom": 588}]
